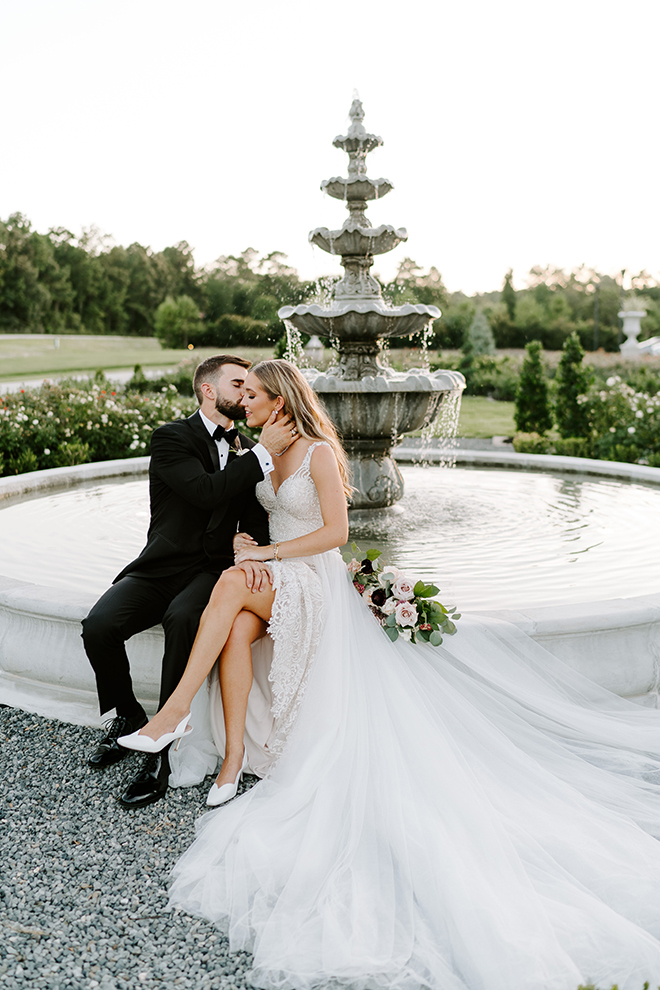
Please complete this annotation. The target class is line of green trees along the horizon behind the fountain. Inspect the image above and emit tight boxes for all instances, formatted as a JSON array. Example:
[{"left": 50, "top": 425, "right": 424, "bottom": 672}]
[{"left": 0, "top": 213, "right": 660, "bottom": 350}]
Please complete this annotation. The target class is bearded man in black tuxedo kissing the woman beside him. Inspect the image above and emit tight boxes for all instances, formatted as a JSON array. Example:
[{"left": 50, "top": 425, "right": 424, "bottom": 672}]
[{"left": 82, "top": 354, "right": 295, "bottom": 808}]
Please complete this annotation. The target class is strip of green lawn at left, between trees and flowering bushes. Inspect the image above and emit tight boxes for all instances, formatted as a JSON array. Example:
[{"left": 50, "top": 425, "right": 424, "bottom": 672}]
[{"left": 0, "top": 334, "right": 272, "bottom": 381}]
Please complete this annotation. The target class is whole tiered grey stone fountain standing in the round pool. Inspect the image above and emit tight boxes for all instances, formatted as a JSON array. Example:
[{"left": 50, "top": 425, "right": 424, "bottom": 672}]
[{"left": 279, "top": 99, "right": 465, "bottom": 509}]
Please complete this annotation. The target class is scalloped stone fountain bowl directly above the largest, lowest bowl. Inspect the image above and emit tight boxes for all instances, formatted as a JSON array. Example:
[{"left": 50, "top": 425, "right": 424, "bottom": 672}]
[{"left": 277, "top": 299, "right": 440, "bottom": 341}]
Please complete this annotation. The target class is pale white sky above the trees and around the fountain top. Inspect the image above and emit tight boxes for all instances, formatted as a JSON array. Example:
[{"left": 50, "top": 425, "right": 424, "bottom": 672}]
[{"left": 0, "top": 0, "right": 660, "bottom": 293}]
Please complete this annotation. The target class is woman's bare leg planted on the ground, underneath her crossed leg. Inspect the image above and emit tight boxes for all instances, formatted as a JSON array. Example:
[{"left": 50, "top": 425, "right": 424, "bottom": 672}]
[{"left": 216, "top": 609, "right": 266, "bottom": 787}]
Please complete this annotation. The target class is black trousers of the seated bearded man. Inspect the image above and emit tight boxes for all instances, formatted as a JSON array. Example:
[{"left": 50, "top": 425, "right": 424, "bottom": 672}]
[{"left": 82, "top": 568, "right": 222, "bottom": 717}]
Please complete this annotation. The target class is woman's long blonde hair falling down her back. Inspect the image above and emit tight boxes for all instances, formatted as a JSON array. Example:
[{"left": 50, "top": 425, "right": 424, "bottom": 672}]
[{"left": 250, "top": 359, "right": 353, "bottom": 498}]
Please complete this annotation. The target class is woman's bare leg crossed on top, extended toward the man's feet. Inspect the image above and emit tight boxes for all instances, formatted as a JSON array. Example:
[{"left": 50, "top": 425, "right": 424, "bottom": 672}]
[{"left": 140, "top": 567, "right": 275, "bottom": 739}]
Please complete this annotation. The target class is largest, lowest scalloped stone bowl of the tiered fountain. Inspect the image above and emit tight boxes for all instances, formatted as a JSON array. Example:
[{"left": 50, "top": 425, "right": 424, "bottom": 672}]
[{"left": 306, "top": 371, "right": 465, "bottom": 446}]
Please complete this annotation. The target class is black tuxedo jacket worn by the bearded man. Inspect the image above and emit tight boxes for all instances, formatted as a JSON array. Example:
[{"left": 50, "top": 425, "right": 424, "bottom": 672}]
[{"left": 113, "top": 412, "right": 269, "bottom": 584}]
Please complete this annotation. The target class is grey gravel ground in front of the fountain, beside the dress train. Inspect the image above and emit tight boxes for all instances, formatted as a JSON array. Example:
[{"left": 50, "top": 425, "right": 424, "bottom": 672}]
[{"left": 0, "top": 707, "right": 256, "bottom": 990}]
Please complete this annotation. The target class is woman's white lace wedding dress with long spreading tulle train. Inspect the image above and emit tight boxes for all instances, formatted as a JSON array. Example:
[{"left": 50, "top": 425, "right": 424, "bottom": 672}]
[{"left": 171, "top": 448, "right": 660, "bottom": 990}]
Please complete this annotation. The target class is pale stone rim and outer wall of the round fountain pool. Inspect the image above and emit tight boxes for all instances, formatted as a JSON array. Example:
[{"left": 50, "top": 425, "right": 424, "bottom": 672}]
[{"left": 0, "top": 454, "right": 660, "bottom": 726}]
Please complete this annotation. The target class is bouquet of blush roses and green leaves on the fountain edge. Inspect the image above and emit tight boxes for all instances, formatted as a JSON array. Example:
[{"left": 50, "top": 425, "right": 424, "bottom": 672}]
[{"left": 344, "top": 543, "right": 461, "bottom": 646}]
